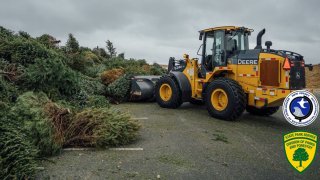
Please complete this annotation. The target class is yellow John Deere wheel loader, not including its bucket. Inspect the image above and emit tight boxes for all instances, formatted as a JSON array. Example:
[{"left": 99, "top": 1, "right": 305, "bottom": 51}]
[{"left": 154, "top": 26, "right": 312, "bottom": 120}]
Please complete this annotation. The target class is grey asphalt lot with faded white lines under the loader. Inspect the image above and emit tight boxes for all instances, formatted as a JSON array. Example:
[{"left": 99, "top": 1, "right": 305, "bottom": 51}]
[{"left": 38, "top": 98, "right": 320, "bottom": 179}]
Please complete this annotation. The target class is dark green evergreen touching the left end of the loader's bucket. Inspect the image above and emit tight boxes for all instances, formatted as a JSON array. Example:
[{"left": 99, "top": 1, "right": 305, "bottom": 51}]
[{"left": 107, "top": 75, "right": 130, "bottom": 102}]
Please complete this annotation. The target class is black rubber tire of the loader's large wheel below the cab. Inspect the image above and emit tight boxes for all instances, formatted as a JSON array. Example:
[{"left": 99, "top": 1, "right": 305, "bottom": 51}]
[{"left": 205, "top": 78, "right": 246, "bottom": 121}]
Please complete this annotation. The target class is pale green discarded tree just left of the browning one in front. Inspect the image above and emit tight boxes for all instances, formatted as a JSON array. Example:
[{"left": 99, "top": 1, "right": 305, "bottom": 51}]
[{"left": 10, "top": 92, "right": 62, "bottom": 156}]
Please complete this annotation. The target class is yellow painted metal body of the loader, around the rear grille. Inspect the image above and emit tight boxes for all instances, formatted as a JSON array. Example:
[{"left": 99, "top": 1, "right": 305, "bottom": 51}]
[{"left": 183, "top": 53, "right": 290, "bottom": 107}]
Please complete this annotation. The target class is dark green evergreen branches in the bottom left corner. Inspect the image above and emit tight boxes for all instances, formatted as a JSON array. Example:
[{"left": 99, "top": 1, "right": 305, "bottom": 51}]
[{"left": 0, "top": 117, "right": 37, "bottom": 179}]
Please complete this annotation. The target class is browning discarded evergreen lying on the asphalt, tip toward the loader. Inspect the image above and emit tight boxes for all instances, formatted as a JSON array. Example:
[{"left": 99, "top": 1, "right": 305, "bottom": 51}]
[{"left": 65, "top": 108, "right": 140, "bottom": 148}]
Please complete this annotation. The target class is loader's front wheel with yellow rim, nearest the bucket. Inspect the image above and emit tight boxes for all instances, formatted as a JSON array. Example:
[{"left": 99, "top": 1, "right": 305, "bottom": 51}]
[{"left": 156, "top": 76, "right": 182, "bottom": 108}]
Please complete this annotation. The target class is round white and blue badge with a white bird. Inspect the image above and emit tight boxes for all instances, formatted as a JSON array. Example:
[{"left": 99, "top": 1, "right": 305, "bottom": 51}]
[{"left": 282, "top": 90, "right": 319, "bottom": 127}]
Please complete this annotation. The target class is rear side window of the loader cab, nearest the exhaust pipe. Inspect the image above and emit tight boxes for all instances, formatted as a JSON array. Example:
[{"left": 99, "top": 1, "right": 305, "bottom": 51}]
[{"left": 227, "top": 32, "right": 249, "bottom": 51}]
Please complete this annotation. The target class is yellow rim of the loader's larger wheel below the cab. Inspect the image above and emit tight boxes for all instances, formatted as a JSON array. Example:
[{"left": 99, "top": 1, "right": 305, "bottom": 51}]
[{"left": 211, "top": 88, "right": 228, "bottom": 111}]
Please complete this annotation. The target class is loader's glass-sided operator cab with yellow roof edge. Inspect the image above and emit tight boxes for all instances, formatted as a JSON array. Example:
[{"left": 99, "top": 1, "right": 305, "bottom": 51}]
[{"left": 198, "top": 26, "right": 250, "bottom": 77}]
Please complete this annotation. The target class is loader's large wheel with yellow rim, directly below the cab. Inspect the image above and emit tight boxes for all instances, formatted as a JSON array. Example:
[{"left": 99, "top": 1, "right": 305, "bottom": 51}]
[{"left": 205, "top": 78, "right": 246, "bottom": 121}]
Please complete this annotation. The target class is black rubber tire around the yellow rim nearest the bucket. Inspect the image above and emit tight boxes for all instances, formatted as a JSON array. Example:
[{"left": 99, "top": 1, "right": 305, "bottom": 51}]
[{"left": 155, "top": 76, "right": 182, "bottom": 109}]
